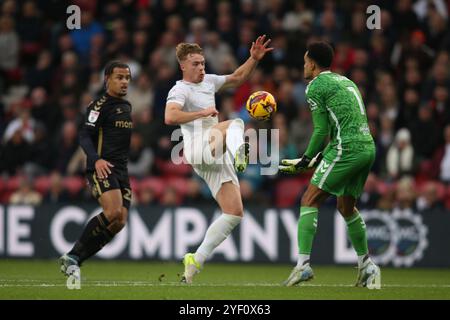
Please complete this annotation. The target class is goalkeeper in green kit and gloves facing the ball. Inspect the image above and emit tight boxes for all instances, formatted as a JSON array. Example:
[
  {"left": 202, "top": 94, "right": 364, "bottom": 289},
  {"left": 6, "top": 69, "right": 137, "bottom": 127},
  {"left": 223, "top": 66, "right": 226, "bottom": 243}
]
[{"left": 279, "top": 42, "right": 381, "bottom": 289}]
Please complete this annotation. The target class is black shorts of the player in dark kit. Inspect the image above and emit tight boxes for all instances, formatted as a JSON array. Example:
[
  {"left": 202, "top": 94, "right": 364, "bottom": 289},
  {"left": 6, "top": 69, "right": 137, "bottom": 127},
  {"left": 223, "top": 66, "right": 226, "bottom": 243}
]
[{"left": 86, "top": 171, "right": 131, "bottom": 210}]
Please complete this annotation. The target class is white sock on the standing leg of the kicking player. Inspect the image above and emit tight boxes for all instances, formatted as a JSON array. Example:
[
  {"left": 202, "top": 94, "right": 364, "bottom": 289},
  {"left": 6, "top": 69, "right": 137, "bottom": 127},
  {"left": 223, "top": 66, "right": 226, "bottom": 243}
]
[{"left": 194, "top": 213, "right": 242, "bottom": 266}]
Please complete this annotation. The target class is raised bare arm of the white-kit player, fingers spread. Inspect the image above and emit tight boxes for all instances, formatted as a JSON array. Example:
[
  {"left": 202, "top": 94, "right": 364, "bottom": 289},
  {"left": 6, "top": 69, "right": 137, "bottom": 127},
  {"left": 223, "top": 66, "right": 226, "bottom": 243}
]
[{"left": 221, "top": 35, "right": 273, "bottom": 89}]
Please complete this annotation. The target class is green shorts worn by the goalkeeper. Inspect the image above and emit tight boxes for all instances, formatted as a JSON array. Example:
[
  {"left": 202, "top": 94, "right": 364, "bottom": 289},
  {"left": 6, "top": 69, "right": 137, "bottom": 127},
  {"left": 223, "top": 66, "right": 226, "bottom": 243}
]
[{"left": 311, "top": 143, "right": 375, "bottom": 199}]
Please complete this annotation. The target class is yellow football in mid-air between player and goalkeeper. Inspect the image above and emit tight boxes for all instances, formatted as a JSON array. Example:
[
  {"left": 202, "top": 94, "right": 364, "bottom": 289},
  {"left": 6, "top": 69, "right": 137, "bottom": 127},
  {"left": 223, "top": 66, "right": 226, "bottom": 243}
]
[{"left": 245, "top": 91, "right": 277, "bottom": 121}]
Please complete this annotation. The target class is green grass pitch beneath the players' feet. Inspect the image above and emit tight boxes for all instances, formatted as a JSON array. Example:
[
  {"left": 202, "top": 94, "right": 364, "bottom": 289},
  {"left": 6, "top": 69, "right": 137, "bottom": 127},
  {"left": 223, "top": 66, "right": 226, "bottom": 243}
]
[{"left": 0, "top": 260, "right": 450, "bottom": 300}]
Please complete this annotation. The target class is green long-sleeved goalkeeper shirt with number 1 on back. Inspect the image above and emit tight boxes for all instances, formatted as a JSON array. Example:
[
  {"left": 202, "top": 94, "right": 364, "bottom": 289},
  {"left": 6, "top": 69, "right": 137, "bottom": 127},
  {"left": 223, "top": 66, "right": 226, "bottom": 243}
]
[{"left": 305, "top": 71, "right": 373, "bottom": 158}]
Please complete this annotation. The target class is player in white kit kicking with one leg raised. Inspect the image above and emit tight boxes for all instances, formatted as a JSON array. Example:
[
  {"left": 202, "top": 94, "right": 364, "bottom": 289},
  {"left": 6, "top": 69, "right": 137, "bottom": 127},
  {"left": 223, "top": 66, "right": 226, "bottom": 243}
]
[{"left": 165, "top": 35, "right": 273, "bottom": 283}]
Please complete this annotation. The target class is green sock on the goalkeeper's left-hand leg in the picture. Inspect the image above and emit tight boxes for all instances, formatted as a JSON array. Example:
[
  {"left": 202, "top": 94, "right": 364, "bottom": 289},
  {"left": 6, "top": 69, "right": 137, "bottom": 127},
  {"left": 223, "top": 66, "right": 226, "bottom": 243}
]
[{"left": 297, "top": 207, "right": 319, "bottom": 255}]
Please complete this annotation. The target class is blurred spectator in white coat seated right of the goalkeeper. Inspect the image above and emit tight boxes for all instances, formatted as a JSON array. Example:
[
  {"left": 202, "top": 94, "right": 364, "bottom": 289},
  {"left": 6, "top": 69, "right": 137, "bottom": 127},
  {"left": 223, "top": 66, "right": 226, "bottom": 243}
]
[{"left": 386, "top": 128, "right": 415, "bottom": 180}]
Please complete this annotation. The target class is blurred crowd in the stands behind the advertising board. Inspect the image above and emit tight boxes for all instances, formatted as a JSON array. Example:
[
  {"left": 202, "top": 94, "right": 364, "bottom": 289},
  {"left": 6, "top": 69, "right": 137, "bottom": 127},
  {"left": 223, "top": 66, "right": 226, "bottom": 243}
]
[{"left": 0, "top": 0, "right": 450, "bottom": 212}]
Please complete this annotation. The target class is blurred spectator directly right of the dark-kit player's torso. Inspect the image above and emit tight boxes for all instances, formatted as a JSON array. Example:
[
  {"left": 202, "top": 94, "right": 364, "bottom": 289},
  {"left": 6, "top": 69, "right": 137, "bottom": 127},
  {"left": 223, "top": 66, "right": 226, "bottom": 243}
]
[{"left": 128, "top": 131, "right": 153, "bottom": 177}]
